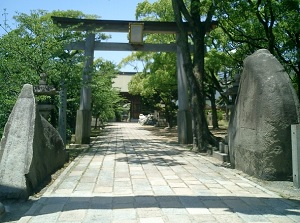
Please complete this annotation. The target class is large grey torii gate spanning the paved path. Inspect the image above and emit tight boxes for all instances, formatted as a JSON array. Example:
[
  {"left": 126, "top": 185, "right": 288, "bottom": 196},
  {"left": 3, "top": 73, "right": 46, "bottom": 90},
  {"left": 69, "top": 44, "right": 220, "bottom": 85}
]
[{"left": 52, "top": 17, "right": 203, "bottom": 144}]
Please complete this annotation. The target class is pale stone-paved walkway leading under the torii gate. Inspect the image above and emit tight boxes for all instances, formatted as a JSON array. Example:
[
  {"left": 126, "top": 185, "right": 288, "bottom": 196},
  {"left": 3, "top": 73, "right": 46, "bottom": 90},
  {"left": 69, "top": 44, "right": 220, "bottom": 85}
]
[{"left": 18, "top": 123, "right": 300, "bottom": 223}]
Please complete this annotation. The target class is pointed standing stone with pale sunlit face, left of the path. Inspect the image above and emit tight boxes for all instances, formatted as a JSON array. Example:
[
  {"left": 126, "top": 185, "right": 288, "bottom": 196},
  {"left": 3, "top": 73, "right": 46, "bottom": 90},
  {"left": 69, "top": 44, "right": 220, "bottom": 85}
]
[{"left": 0, "top": 84, "right": 68, "bottom": 199}]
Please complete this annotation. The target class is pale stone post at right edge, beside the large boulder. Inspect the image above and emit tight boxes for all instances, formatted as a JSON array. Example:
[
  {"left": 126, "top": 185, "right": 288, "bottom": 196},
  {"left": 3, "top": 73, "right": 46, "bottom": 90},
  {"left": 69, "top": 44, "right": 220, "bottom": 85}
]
[{"left": 291, "top": 124, "right": 300, "bottom": 188}]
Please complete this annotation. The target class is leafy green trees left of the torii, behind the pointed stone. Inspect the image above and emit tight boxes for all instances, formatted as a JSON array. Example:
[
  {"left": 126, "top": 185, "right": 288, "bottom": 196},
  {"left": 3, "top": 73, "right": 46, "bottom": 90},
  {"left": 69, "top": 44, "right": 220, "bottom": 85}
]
[{"left": 0, "top": 10, "right": 110, "bottom": 139}]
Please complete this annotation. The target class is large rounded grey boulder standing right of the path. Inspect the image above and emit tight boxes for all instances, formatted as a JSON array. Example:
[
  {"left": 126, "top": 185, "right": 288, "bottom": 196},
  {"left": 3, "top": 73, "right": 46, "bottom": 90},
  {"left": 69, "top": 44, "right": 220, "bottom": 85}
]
[{"left": 228, "top": 49, "right": 299, "bottom": 180}]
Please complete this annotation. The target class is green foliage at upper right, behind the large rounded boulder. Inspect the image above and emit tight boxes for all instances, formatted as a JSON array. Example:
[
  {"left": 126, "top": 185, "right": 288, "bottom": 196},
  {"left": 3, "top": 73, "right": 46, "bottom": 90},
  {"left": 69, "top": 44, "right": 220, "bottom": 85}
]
[{"left": 205, "top": 0, "right": 300, "bottom": 107}]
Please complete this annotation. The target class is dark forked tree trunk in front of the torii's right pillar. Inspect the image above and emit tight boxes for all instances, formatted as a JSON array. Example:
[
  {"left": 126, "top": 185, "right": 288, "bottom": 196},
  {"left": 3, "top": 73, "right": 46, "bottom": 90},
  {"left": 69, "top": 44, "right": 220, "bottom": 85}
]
[{"left": 172, "top": 0, "right": 217, "bottom": 151}]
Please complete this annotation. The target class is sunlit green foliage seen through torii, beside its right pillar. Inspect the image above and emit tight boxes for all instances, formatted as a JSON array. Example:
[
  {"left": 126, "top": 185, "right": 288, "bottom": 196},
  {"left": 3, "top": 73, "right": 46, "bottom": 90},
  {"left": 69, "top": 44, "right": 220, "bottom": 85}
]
[{"left": 122, "top": 0, "right": 177, "bottom": 126}]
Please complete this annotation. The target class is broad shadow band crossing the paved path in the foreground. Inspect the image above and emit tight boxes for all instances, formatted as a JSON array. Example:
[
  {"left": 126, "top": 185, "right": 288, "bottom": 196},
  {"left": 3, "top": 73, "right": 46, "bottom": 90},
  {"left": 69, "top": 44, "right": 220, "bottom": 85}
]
[{"left": 17, "top": 195, "right": 300, "bottom": 219}]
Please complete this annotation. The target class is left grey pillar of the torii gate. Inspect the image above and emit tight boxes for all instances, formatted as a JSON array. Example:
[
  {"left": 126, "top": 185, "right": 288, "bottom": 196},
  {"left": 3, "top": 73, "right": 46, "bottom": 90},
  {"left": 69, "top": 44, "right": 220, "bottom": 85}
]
[{"left": 75, "top": 33, "right": 95, "bottom": 144}]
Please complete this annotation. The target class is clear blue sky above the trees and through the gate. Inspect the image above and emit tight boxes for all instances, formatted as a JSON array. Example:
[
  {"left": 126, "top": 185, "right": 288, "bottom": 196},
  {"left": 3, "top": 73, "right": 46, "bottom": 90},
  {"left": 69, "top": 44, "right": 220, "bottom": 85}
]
[{"left": 0, "top": 0, "right": 155, "bottom": 72}]
